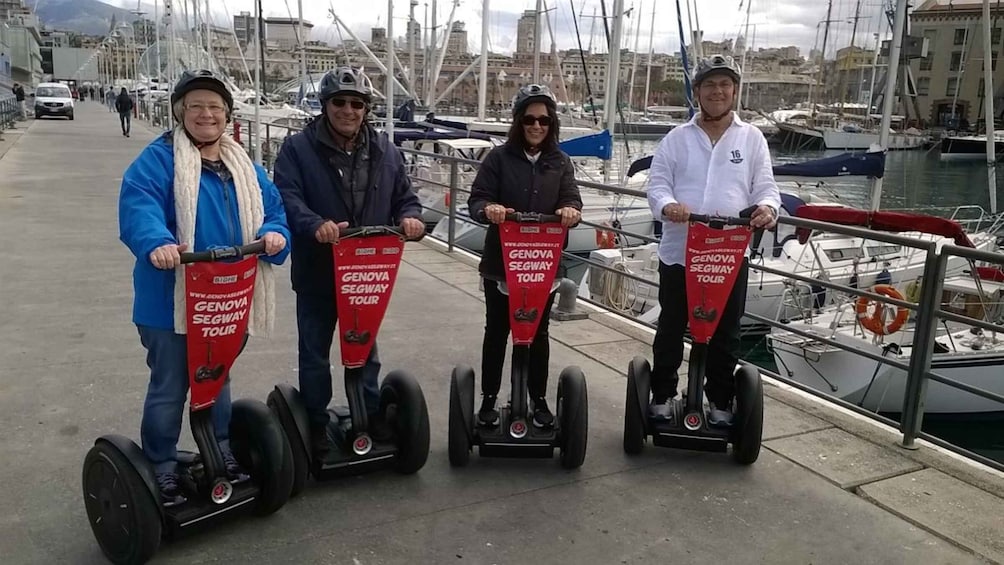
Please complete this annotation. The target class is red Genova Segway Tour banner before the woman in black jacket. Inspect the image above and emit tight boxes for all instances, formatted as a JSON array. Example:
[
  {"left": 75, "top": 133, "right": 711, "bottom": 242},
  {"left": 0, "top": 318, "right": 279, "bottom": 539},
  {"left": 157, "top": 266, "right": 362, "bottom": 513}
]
[{"left": 499, "top": 222, "right": 565, "bottom": 345}]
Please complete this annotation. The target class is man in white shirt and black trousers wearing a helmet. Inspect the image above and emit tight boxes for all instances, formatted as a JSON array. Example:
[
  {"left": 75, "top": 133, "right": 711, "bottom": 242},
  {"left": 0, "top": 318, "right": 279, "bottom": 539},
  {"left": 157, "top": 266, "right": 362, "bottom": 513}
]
[{"left": 649, "top": 55, "right": 781, "bottom": 423}]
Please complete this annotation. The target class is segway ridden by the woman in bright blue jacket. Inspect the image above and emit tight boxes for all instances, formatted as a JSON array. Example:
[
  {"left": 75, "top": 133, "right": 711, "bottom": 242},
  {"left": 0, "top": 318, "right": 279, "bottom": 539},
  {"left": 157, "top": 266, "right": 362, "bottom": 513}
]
[{"left": 83, "top": 242, "right": 293, "bottom": 563}]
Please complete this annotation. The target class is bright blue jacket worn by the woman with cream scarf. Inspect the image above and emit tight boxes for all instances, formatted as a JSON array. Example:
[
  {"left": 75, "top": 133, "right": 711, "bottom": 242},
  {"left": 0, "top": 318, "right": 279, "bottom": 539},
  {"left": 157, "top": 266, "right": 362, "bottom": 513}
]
[{"left": 118, "top": 134, "right": 290, "bottom": 329}]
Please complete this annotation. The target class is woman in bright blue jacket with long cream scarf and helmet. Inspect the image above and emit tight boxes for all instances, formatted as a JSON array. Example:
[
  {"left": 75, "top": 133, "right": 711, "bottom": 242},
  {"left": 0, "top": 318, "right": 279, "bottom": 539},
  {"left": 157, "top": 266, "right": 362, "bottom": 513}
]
[{"left": 118, "top": 70, "right": 289, "bottom": 506}]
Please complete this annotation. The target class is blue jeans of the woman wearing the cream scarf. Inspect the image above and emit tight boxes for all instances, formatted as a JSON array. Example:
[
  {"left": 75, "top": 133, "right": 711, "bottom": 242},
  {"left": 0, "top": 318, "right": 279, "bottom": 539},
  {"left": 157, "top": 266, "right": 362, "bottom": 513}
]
[{"left": 137, "top": 325, "right": 230, "bottom": 473}]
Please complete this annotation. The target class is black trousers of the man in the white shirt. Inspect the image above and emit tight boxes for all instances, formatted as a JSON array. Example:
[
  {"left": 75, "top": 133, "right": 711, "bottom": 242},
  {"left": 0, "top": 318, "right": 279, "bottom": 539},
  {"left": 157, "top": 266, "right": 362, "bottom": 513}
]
[{"left": 652, "top": 259, "right": 749, "bottom": 406}]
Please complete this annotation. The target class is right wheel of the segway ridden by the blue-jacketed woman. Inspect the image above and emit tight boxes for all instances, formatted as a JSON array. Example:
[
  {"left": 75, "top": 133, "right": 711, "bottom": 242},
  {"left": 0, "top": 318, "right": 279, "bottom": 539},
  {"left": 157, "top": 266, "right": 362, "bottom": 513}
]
[{"left": 230, "top": 398, "right": 293, "bottom": 516}]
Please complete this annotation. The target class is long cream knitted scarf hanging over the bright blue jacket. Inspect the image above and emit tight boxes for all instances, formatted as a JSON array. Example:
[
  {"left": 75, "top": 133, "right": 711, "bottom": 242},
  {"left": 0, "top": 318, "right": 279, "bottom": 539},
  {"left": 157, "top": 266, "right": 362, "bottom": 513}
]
[{"left": 174, "top": 126, "right": 275, "bottom": 336}]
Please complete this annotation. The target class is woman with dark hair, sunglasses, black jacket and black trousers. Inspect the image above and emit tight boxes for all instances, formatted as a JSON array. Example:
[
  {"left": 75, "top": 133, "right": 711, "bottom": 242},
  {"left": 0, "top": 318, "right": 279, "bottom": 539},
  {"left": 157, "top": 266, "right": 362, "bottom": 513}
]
[{"left": 468, "top": 84, "right": 582, "bottom": 428}]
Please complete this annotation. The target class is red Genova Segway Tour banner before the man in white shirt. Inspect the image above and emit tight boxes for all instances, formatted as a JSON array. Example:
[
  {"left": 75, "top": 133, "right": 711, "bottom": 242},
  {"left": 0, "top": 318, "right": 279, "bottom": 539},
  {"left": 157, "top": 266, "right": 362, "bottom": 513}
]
[{"left": 687, "top": 223, "right": 753, "bottom": 343}]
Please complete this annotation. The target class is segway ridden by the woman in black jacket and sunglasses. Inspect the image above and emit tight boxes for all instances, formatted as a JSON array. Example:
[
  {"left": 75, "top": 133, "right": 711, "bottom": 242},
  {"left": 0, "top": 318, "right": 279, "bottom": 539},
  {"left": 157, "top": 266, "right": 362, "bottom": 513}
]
[{"left": 449, "top": 213, "right": 588, "bottom": 469}]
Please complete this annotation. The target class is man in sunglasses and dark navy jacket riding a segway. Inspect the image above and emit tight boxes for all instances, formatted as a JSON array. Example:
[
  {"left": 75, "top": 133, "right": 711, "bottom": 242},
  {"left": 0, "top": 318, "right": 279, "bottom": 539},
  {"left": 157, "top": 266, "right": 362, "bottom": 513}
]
[{"left": 275, "top": 66, "right": 425, "bottom": 461}]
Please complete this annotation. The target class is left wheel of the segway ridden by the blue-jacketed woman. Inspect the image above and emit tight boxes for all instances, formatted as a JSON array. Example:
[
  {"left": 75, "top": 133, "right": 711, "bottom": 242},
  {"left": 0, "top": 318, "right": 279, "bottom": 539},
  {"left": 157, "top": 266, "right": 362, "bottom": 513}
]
[{"left": 83, "top": 441, "right": 163, "bottom": 563}]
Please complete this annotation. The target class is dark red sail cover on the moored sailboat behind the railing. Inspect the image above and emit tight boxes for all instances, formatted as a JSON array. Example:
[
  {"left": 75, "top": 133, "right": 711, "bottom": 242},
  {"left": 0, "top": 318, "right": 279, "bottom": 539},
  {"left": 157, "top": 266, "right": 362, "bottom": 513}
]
[{"left": 795, "top": 206, "right": 974, "bottom": 247}]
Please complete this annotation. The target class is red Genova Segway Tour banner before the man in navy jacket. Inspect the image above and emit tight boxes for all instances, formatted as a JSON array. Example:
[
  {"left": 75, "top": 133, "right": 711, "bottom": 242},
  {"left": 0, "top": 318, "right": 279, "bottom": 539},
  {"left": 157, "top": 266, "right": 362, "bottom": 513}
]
[{"left": 331, "top": 234, "right": 405, "bottom": 368}]
